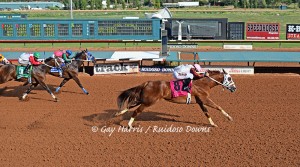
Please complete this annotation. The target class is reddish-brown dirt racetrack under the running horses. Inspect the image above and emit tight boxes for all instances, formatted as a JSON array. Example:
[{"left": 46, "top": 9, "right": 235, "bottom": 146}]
[{"left": 0, "top": 74, "right": 300, "bottom": 167}]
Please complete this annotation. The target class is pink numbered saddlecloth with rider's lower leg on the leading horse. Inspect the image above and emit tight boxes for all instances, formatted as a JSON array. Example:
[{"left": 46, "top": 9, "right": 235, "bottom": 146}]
[{"left": 170, "top": 78, "right": 192, "bottom": 104}]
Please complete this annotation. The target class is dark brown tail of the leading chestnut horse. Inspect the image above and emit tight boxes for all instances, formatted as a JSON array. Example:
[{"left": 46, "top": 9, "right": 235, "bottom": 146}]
[{"left": 117, "top": 82, "right": 148, "bottom": 110}]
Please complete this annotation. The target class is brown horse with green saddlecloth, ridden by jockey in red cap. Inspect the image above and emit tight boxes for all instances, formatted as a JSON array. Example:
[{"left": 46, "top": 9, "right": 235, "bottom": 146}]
[{"left": 0, "top": 57, "right": 58, "bottom": 102}]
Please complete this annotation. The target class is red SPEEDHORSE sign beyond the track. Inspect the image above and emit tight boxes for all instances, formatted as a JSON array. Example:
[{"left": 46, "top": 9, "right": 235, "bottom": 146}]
[{"left": 246, "top": 23, "right": 280, "bottom": 40}]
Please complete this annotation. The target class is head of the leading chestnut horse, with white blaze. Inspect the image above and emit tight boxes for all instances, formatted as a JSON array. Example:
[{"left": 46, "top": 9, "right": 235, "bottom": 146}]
[{"left": 208, "top": 69, "right": 236, "bottom": 92}]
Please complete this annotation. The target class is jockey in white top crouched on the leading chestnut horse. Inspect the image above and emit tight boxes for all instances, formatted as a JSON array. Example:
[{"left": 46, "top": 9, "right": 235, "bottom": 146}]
[{"left": 173, "top": 64, "right": 209, "bottom": 80}]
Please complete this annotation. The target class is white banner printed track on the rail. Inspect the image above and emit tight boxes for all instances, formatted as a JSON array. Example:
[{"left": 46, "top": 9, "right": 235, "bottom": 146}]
[{"left": 94, "top": 63, "right": 139, "bottom": 74}]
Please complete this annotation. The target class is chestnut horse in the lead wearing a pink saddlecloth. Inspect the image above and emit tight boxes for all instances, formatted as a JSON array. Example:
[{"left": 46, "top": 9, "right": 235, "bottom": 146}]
[{"left": 115, "top": 70, "right": 236, "bottom": 128}]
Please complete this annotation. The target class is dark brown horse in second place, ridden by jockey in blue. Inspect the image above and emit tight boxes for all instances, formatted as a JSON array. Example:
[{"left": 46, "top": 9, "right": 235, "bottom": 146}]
[{"left": 49, "top": 49, "right": 95, "bottom": 95}]
